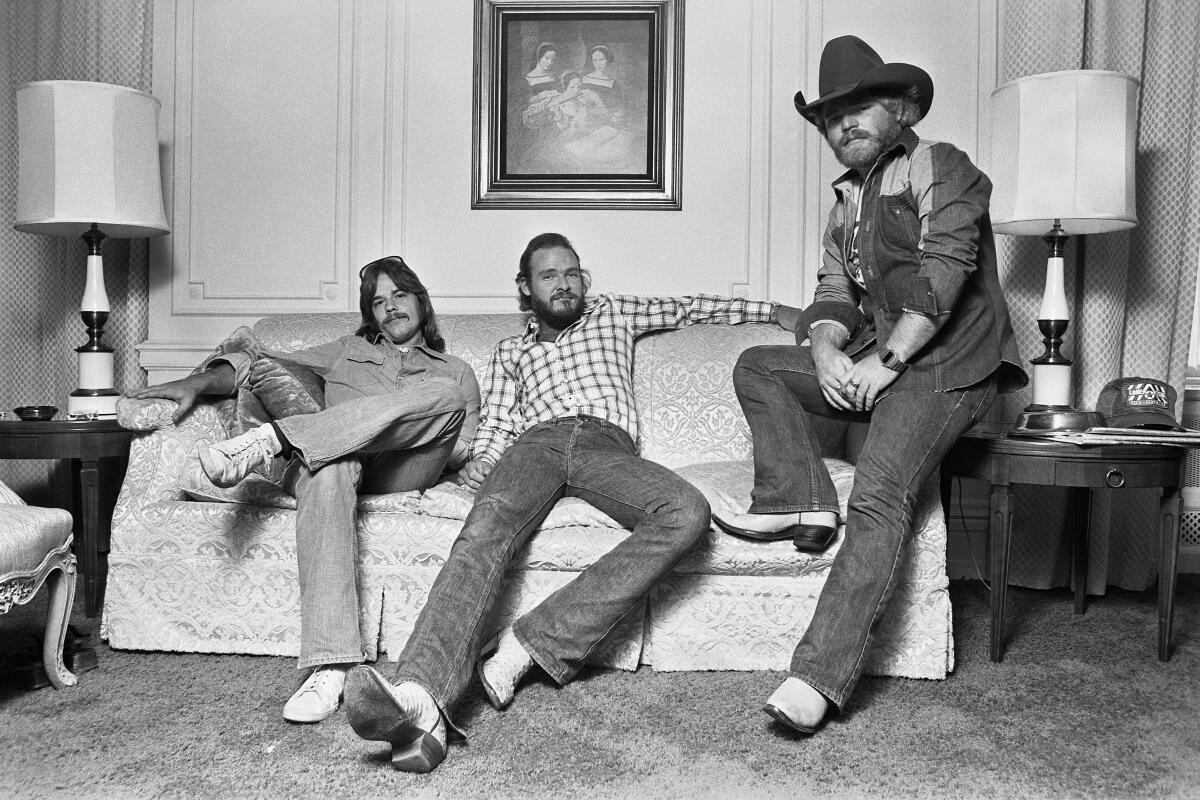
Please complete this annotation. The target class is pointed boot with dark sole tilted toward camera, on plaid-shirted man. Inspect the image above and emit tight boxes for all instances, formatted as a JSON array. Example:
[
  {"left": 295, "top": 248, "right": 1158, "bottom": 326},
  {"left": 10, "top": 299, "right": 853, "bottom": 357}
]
[{"left": 346, "top": 664, "right": 446, "bottom": 772}]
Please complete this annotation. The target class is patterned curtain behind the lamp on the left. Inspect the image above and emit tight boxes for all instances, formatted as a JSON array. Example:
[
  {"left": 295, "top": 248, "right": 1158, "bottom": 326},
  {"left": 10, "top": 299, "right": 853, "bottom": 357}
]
[{"left": 0, "top": 0, "right": 152, "bottom": 503}]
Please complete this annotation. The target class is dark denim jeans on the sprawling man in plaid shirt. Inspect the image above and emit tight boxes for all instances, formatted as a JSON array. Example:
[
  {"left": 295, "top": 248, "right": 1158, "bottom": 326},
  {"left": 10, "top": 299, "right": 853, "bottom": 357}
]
[{"left": 395, "top": 416, "right": 709, "bottom": 718}]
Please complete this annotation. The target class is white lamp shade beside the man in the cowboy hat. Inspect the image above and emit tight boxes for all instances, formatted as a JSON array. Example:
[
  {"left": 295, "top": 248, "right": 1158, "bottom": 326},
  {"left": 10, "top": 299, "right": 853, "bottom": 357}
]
[{"left": 991, "top": 70, "right": 1138, "bottom": 236}]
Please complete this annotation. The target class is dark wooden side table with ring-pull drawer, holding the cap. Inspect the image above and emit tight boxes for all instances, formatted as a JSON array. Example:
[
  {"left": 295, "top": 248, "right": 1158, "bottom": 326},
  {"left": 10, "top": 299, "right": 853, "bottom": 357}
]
[{"left": 942, "top": 427, "right": 1187, "bottom": 661}]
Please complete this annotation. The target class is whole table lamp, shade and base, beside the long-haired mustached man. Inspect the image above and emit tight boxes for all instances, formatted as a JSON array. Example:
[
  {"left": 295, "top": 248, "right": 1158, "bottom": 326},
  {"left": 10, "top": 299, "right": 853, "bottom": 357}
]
[{"left": 13, "top": 80, "right": 170, "bottom": 417}]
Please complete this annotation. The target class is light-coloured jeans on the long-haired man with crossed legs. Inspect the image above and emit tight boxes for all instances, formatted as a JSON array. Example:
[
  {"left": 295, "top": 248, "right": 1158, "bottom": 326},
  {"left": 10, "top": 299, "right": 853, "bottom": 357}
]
[{"left": 276, "top": 378, "right": 466, "bottom": 669}]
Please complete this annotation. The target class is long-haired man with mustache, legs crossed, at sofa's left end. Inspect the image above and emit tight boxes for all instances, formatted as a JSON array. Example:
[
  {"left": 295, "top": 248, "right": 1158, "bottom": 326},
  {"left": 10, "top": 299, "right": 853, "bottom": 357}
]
[{"left": 128, "top": 255, "right": 479, "bottom": 722}]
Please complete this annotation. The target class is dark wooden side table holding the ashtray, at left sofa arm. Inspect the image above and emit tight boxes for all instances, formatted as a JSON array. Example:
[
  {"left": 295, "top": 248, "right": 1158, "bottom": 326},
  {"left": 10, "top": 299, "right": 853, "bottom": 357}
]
[{"left": 0, "top": 420, "right": 133, "bottom": 616}]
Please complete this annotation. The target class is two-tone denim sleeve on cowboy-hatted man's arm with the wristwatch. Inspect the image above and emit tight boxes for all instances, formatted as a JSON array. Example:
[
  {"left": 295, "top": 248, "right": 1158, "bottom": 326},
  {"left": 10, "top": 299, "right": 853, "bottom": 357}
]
[{"left": 901, "top": 142, "right": 991, "bottom": 317}]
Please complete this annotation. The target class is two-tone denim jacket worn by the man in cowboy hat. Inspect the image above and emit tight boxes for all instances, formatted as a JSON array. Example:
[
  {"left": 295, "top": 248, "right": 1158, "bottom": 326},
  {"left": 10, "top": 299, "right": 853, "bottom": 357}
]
[{"left": 797, "top": 130, "right": 1028, "bottom": 391}]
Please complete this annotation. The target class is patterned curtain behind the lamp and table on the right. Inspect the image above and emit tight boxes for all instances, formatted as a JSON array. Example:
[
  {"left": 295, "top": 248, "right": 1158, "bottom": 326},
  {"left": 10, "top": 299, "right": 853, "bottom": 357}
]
[{"left": 994, "top": 0, "right": 1200, "bottom": 594}]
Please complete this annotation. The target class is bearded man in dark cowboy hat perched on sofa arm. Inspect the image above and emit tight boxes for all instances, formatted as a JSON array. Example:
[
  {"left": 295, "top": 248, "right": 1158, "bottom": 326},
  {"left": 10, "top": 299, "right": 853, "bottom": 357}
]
[{"left": 716, "top": 36, "right": 1027, "bottom": 734}]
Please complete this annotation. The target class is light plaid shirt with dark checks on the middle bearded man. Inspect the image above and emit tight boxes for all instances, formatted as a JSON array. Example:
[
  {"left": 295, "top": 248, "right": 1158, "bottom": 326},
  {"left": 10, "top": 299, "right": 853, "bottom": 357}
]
[{"left": 472, "top": 294, "right": 778, "bottom": 463}]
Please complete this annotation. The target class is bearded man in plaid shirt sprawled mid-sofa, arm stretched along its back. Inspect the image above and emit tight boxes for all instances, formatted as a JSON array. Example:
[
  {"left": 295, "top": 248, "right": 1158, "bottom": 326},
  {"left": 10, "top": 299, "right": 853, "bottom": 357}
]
[{"left": 346, "top": 234, "right": 799, "bottom": 772}]
